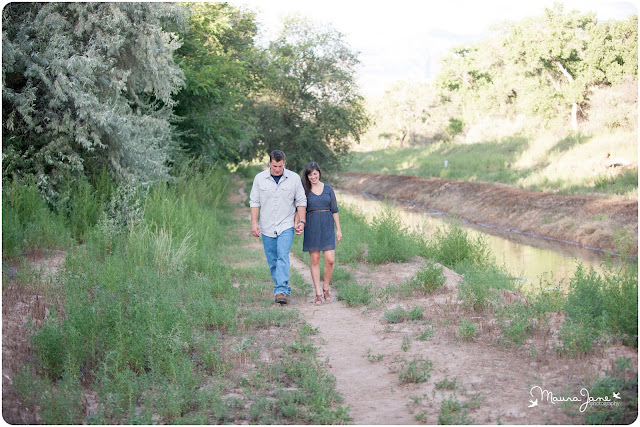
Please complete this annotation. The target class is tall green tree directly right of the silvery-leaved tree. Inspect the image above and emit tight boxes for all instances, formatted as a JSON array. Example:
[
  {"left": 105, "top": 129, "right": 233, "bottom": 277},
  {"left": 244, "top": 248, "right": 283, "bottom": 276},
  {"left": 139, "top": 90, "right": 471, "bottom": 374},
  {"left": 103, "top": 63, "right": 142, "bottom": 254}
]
[{"left": 175, "top": 3, "right": 258, "bottom": 163}]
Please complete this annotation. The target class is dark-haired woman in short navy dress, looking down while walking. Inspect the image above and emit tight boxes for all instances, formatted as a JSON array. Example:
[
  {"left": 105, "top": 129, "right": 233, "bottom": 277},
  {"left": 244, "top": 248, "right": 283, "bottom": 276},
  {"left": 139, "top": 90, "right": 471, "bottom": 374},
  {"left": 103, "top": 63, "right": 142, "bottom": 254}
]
[{"left": 301, "top": 162, "right": 342, "bottom": 305}]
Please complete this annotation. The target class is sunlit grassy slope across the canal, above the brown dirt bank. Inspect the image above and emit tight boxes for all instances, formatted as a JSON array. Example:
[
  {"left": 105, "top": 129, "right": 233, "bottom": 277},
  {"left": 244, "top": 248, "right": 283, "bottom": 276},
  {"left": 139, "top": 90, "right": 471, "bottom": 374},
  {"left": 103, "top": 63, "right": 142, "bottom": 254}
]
[{"left": 348, "top": 130, "right": 638, "bottom": 198}]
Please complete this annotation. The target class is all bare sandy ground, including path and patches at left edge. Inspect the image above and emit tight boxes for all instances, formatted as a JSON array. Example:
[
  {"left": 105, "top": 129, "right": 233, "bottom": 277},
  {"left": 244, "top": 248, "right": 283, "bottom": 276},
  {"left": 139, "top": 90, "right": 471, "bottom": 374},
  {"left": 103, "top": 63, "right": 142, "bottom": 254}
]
[{"left": 2, "top": 178, "right": 638, "bottom": 425}]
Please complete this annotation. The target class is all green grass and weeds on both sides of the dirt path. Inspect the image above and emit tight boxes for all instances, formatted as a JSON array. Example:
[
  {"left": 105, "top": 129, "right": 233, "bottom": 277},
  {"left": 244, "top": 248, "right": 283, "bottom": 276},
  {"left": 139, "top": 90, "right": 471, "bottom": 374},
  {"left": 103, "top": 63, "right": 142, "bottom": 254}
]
[{"left": 3, "top": 168, "right": 638, "bottom": 424}]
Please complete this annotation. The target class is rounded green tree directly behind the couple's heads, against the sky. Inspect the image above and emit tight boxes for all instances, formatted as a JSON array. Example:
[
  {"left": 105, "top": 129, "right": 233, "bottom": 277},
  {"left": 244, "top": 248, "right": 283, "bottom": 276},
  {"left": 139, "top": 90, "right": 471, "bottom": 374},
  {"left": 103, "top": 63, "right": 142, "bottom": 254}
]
[{"left": 249, "top": 17, "right": 368, "bottom": 170}]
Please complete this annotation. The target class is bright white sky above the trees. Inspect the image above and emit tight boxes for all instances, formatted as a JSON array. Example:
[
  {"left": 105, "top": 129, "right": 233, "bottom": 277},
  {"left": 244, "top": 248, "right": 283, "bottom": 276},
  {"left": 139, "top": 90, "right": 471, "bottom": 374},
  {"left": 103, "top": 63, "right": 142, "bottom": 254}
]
[{"left": 227, "top": 0, "right": 638, "bottom": 95}]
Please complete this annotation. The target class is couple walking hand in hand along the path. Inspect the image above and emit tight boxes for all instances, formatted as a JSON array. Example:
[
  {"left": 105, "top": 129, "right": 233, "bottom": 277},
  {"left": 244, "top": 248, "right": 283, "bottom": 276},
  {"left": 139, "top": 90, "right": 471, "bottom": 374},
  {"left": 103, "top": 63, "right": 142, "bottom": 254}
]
[{"left": 249, "top": 150, "right": 342, "bottom": 305}]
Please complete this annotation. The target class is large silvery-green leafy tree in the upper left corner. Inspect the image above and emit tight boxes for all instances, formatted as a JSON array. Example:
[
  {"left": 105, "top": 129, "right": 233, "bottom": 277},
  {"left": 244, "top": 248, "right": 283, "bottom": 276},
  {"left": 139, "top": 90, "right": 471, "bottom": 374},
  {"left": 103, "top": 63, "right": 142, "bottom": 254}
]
[{"left": 2, "top": 3, "right": 185, "bottom": 204}]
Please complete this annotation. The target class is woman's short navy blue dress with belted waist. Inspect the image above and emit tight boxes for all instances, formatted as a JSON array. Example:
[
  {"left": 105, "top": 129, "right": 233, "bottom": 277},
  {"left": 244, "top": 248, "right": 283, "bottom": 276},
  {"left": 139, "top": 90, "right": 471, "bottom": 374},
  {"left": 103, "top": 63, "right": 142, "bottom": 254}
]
[{"left": 302, "top": 184, "right": 338, "bottom": 252}]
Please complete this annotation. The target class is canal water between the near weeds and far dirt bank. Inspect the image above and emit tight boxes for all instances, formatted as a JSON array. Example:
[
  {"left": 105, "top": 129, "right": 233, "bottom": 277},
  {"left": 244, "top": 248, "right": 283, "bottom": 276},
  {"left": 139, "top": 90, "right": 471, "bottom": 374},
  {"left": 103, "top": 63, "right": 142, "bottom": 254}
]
[{"left": 335, "top": 189, "right": 605, "bottom": 290}]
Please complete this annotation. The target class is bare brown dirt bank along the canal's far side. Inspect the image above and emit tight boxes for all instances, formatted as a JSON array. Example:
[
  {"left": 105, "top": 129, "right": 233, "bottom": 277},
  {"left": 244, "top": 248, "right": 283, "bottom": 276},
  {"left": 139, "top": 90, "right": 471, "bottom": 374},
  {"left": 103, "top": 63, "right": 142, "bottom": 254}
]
[{"left": 338, "top": 172, "right": 638, "bottom": 253}]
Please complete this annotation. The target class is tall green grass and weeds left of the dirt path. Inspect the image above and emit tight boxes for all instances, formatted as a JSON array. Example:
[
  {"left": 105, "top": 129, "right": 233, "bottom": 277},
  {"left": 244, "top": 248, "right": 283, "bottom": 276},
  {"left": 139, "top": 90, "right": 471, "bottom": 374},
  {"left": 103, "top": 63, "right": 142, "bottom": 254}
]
[{"left": 16, "top": 168, "right": 349, "bottom": 424}]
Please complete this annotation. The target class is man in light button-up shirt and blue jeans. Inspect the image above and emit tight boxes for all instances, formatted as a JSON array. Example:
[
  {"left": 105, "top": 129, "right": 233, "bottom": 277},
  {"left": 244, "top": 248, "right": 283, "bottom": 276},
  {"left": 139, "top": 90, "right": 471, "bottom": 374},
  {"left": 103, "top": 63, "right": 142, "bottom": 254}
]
[{"left": 249, "top": 150, "right": 307, "bottom": 304}]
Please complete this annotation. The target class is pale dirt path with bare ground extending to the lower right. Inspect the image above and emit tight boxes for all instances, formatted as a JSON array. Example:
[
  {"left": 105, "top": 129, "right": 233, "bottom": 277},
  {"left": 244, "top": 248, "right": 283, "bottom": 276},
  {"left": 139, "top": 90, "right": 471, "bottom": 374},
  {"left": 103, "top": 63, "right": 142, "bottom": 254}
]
[{"left": 292, "top": 254, "right": 638, "bottom": 425}]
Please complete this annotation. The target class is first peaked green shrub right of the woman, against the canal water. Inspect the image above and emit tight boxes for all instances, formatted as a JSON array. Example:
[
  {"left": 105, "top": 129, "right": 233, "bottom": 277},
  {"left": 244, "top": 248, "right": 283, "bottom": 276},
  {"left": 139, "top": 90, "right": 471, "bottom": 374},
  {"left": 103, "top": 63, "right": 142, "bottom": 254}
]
[{"left": 367, "top": 204, "right": 417, "bottom": 264}]
